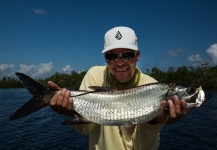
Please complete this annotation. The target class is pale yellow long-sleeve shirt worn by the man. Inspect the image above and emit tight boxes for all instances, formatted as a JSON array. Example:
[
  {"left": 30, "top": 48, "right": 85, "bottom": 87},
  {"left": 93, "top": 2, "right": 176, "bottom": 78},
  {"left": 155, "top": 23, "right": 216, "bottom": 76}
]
[{"left": 73, "top": 66, "right": 162, "bottom": 150}]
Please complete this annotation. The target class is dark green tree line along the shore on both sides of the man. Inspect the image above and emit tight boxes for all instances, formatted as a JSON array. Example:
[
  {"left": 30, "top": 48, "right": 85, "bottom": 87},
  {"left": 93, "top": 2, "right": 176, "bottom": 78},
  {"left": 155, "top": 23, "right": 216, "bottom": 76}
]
[{"left": 0, "top": 64, "right": 217, "bottom": 90}]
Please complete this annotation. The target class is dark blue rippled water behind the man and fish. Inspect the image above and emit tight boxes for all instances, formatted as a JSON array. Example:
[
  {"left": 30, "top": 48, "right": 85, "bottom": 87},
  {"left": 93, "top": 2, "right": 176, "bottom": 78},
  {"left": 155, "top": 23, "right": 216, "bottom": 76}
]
[{"left": 0, "top": 88, "right": 217, "bottom": 150}]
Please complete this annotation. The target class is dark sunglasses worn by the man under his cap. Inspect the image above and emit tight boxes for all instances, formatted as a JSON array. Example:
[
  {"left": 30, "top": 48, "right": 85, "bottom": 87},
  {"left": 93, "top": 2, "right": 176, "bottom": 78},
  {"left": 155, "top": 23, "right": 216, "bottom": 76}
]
[{"left": 104, "top": 51, "right": 137, "bottom": 62}]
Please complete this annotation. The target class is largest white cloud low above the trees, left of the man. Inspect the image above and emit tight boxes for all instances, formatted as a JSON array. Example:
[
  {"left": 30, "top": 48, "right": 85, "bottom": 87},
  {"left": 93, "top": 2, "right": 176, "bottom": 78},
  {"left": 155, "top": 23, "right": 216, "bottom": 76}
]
[{"left": 18, "top": 62, "right": 54, "bottom": 78}]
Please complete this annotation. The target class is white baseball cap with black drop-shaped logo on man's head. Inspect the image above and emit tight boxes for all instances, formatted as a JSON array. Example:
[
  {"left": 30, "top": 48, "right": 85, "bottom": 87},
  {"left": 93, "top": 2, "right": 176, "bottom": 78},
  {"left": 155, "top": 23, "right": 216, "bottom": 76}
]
[{"left": 102, "top": 26, "right": 138, "bottom": 53}]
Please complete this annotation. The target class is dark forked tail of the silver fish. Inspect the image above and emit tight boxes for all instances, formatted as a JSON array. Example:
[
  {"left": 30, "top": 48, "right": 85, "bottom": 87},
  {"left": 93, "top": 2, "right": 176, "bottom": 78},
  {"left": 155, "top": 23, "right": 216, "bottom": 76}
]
[{"left": 9, "top": 72, "right": 53, "bottom": 120}]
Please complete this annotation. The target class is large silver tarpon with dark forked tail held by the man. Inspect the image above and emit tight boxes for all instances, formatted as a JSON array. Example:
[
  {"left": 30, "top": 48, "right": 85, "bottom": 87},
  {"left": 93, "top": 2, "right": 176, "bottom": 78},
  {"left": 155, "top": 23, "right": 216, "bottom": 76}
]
[{"left": 9, "top": 73, "right": 210, "bottom": 125}]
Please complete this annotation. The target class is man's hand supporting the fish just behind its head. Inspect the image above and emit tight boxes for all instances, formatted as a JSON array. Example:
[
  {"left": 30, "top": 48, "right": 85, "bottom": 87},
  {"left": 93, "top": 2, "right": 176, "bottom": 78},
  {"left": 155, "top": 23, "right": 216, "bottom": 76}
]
[{"left": 154, "top": 95, "right": 187, "bottom": 123}]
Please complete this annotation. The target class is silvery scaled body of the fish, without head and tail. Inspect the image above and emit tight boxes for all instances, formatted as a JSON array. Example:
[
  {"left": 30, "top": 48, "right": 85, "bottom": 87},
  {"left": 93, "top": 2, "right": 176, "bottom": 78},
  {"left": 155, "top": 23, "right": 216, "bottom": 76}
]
[{"left": 71, "top": 84, "right": 169, "bottom": 125}]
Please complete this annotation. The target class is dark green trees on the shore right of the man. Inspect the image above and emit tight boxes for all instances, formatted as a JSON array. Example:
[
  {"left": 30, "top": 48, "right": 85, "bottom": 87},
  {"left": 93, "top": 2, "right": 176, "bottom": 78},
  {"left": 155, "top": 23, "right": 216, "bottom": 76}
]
[{"left": 146, "top": 64, "right": 217, "bottom": 89}]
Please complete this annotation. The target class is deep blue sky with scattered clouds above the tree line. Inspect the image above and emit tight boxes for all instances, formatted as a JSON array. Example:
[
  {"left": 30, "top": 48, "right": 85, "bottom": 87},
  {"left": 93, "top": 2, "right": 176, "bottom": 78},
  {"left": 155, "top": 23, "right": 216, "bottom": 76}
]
[{"left": 0, "top": 0, "right": 217, "bottom": 78}]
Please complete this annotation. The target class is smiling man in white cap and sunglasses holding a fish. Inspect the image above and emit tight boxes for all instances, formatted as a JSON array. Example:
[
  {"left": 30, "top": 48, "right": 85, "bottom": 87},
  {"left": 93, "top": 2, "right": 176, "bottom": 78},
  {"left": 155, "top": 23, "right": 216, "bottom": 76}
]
[{"left": 48, "top": 27, "right": 186, "bottom": 150}]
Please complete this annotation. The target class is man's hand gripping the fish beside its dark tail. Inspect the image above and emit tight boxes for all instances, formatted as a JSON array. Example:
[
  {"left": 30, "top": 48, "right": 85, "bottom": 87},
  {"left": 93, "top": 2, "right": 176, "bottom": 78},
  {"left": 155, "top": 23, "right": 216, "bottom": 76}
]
[{"left": 48, "top": 81, "right": 73, "bottom": 116}]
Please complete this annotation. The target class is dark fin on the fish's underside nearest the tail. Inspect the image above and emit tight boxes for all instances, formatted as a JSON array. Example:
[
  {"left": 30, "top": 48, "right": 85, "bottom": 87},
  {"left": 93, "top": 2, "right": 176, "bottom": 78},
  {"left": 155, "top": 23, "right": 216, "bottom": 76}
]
[{"left": 62, "top": 111, "right": 92, "bottom": 125}]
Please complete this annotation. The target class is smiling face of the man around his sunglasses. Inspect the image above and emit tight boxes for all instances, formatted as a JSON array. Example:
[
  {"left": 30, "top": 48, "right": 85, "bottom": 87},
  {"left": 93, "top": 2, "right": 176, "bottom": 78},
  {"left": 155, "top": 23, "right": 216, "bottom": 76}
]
[{"left": 106, "top": 48, "right": 140, "bottom": 83}]
